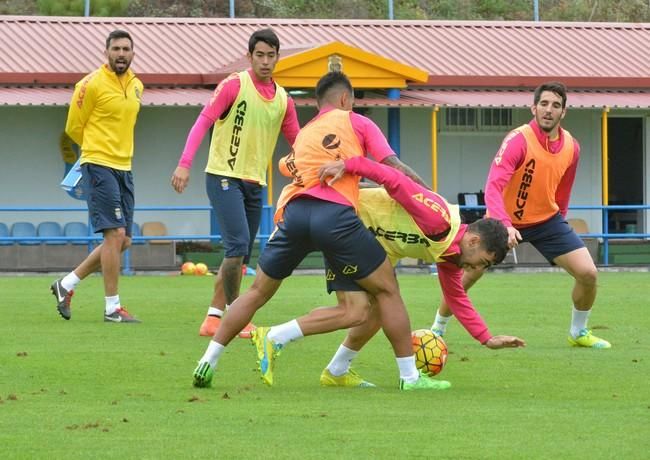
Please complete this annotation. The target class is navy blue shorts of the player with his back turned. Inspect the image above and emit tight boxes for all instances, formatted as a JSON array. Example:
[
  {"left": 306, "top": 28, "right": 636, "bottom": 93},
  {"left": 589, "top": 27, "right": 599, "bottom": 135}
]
[{"left": 258, "top": 197, "right": 386, "bottom": 290}]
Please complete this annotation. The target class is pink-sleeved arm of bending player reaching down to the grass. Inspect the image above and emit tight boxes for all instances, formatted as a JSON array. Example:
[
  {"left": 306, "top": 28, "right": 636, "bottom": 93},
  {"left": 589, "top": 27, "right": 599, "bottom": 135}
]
[{"left": 437, "top": 262, "right": 526, "bottom": 349}]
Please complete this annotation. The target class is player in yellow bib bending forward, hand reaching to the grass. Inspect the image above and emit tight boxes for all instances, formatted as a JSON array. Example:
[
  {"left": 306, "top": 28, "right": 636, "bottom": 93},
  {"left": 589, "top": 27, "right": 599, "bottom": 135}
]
[{"left": 320, "top": 157, "right": 525, "bottom": 387}]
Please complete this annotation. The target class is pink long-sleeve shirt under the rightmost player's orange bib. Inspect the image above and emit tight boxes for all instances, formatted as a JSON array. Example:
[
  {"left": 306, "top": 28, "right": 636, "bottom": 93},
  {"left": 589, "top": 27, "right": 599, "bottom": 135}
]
[{"left": 485, "top": 120, "right": 580, "bottom": 227}]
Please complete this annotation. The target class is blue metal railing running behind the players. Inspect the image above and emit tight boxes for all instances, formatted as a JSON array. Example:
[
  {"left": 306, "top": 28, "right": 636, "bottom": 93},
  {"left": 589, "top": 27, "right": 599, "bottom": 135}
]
[{"left": 0, "top": 205, "right": 650, "bottom": 273}]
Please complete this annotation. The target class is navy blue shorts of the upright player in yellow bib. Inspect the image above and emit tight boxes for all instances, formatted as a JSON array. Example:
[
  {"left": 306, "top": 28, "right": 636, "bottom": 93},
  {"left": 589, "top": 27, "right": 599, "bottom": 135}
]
[{"left": 205, "top": 173, "right": 262, "bottom": 263}]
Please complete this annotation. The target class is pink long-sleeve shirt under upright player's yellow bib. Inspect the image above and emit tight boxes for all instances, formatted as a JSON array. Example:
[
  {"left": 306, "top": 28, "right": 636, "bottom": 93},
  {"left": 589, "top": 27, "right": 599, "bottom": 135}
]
[{"left": 178, "top": 69, "right": 300, "bottom": 169}]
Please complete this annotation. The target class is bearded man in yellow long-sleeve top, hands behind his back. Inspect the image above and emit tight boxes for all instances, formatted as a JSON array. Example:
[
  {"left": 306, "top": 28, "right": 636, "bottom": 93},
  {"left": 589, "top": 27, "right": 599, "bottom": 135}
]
[{"left": 51, "top": 30, "right": 144, "bottom": 323}]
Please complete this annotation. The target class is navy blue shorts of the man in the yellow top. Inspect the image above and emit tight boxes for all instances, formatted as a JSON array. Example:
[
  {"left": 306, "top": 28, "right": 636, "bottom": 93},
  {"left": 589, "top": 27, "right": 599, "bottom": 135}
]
[{"left": 81, "top": 163, "right": 135, "bottom": 236}]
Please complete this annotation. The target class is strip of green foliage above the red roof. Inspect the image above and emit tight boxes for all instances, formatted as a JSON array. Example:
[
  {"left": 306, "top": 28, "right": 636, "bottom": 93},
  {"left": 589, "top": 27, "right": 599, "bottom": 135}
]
[{"left": 0, "top": 0, "right": 650, "bottom": 22}]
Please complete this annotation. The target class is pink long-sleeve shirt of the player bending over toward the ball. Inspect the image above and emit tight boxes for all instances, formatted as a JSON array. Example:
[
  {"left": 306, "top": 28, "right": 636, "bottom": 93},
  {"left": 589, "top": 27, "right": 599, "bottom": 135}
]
[{"left": 345, "top": 157, "right": 492, "bottom": 343}]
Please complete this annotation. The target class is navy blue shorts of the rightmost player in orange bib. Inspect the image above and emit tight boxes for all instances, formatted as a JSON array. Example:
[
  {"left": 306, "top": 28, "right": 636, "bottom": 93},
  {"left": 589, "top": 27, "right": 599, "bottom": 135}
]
[{"left": 517, "top": 213, "right": 585, "bottom": 265}]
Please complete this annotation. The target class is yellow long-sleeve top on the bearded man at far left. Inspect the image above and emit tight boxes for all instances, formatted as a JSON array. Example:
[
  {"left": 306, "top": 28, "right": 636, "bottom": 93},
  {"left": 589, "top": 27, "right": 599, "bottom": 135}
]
[{"left": 65, "top": 64, "right": 144, "bottom": 171}]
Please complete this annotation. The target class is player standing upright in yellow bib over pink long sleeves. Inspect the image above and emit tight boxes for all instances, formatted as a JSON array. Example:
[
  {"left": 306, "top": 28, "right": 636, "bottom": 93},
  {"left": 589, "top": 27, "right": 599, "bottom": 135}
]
[{"left": 171, "top": 29, "right": 300, "bottom": 337}]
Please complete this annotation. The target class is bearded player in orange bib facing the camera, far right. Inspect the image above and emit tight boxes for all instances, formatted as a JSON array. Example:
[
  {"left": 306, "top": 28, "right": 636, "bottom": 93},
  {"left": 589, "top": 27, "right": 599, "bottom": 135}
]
[{"left": 432, "top": 82, "right": 611, "bottom": 348}]
